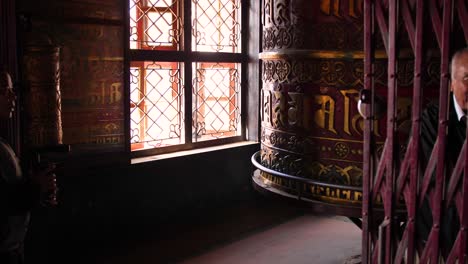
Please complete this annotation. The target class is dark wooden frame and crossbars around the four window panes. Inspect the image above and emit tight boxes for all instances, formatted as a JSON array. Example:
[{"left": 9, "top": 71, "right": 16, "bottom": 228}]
[{"left": 124, "top": 0, "right": 249, "bottom": 157}]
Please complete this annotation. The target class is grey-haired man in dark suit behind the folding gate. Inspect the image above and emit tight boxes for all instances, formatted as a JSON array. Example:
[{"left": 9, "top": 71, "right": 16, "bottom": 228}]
[{"left": 417, "top": 48, "right": 468, "bottom": 254}]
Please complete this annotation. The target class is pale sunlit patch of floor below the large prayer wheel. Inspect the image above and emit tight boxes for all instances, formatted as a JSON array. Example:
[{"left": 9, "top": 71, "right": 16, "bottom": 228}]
[{"left": 181, "top": 215, "right": 361, "bottom": 264}]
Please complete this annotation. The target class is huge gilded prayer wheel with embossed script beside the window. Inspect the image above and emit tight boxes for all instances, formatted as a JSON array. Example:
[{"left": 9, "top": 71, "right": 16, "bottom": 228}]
[{"left": 252, "top": 0, "right": 420, "bottom": 215}]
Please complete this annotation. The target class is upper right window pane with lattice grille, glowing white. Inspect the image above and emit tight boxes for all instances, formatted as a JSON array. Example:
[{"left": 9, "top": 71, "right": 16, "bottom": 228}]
[{"left": 192, "top": 0, "right": 241, "bottom": 53}]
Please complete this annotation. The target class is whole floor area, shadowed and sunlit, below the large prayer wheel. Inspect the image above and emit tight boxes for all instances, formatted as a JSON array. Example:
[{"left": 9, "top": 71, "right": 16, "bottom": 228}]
[{"left": 90, "top": 199, "right": 361, "bottom": 264}]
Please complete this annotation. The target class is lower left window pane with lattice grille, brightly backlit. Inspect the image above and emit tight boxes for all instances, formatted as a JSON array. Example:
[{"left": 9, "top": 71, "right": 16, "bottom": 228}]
[{"left": 130, "top": 62, "right": 184, "bottom": 150}]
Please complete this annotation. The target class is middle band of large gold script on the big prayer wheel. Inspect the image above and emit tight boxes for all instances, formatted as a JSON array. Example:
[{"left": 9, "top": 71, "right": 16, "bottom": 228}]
[{"left": 261, "top": 87, "right": 386, "bottom": 137}]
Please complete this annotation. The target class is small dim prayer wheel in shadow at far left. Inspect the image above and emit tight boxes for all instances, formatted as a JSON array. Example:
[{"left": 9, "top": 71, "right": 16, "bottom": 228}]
[{"left": 23, "top": 34, "right": 62, "bottom": 148}]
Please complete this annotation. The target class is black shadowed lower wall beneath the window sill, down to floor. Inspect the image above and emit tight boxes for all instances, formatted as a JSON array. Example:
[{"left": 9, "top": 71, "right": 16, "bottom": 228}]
[{"left": 26, "top": 144, "right": 259, "bottom": 263}]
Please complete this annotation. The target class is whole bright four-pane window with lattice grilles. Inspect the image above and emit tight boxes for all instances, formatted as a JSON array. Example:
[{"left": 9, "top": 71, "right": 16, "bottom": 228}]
[{"left": 126, "top": 0, "right": 247, "bottom": 154}]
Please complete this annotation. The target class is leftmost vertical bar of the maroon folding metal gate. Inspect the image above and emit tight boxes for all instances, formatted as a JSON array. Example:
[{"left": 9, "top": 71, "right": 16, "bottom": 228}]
[{"left": 361, "top": 0, "right": 373, "bottom": 263}]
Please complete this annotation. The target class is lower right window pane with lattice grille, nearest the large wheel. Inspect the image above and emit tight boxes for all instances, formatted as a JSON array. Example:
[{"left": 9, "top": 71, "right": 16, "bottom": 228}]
[{"left": 192, "top": 63, "right": 241, "bottom": 142}]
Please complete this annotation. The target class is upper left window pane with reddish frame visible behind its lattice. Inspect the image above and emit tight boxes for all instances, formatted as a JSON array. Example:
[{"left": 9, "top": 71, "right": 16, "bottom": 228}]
[{"left": 130, "top": 0, "right": 182, "bottom": 50}]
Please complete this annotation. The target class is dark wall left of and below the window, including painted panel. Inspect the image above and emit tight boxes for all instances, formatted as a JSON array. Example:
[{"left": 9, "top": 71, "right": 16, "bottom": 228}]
[{"left": 17, "top": 0, "right": 259, "bottom": 261}]
